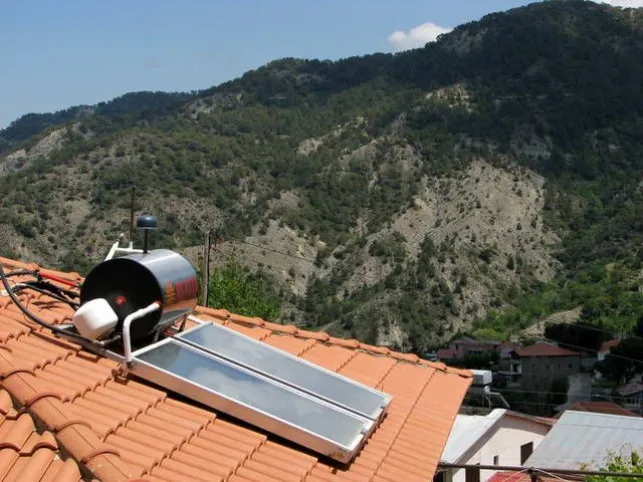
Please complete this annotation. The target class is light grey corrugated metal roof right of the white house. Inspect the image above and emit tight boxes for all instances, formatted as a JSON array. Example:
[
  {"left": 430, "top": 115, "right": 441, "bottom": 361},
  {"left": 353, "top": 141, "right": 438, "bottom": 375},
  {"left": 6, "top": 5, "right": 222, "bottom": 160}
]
[{"left": 523, "top": 410, "right": 643, "bottom": 470}]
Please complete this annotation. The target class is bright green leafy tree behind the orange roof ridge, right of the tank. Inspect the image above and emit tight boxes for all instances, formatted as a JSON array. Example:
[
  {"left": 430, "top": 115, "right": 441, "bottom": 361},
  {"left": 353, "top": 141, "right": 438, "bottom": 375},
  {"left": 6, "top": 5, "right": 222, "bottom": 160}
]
[{"left": 208, "top": 258, "right": 280, "bottom": 320}]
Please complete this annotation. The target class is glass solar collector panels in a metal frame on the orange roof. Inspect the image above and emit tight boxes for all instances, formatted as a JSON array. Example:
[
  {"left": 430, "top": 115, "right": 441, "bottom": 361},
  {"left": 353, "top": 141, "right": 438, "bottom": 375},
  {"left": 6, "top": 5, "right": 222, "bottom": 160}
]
[{"left": 130, "top": 323, "right": 391, "bottom": 462}]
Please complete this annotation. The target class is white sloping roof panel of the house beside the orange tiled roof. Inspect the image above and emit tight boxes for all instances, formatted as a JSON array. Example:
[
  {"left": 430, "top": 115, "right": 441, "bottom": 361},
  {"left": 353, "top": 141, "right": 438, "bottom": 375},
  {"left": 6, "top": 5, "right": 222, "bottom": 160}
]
[{"left": 440, "top": 408, "right": 506, "bottom": 464}]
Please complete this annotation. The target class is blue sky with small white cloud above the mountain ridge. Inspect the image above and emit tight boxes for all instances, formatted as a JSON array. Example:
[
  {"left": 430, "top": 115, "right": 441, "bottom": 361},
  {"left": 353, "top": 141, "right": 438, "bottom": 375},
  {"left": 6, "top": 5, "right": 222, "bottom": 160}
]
[{"left": 0, "top": 0, "right": 643, "bottom": 128}]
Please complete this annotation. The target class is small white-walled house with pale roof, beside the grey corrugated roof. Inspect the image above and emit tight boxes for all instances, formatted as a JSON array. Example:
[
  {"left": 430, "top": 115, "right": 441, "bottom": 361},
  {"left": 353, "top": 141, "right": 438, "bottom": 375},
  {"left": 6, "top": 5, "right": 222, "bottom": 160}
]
[{"left": 434, "top": 408, "right": 555, "bottom": 482}]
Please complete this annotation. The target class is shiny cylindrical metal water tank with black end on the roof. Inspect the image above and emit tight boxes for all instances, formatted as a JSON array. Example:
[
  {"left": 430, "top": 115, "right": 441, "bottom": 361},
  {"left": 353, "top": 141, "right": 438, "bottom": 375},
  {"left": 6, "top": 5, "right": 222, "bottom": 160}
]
[{"left": 80, "top": 249, "right": 199, "bottom": 342}]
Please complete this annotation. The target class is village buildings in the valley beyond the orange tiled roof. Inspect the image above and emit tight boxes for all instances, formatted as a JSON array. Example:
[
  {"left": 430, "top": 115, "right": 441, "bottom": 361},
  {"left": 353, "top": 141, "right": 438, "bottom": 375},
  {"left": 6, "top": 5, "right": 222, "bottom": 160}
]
[{"left": 430, "top": 336, "right": 643, "bottom": 482}]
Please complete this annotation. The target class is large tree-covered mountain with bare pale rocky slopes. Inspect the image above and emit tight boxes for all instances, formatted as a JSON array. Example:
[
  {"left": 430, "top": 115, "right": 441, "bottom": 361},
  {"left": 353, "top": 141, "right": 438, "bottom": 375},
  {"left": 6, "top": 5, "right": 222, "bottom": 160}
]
[{"left": 0, "top": 0, "right": 643, "bottom": 352}]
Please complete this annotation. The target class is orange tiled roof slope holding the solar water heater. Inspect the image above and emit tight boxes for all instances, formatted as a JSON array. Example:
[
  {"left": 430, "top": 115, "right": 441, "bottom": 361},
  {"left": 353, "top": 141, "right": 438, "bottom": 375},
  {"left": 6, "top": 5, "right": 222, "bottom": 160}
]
[{"left": 0, "top": 258, "right": 471, "bottom": 482}]
